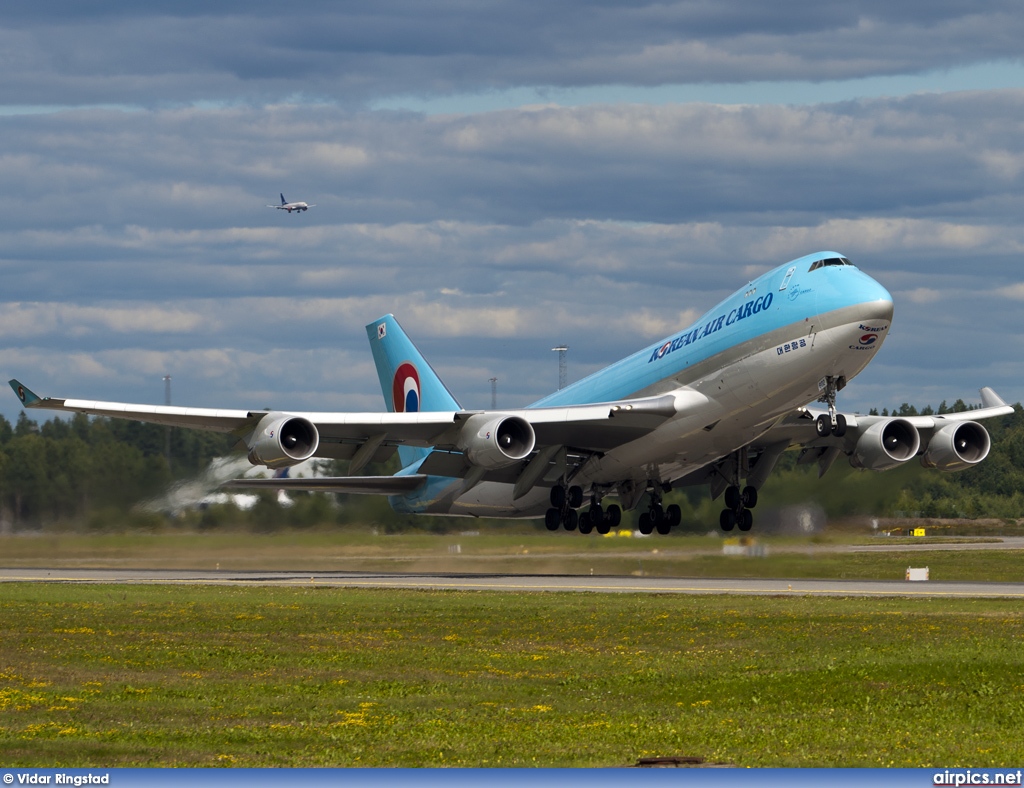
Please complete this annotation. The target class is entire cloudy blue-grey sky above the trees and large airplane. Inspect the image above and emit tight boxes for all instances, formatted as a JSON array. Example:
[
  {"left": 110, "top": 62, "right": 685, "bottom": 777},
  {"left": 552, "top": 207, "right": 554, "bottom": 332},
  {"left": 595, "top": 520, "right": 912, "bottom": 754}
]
[{"left": 0, "top": 0, "right": 1024, "bottom": 421}]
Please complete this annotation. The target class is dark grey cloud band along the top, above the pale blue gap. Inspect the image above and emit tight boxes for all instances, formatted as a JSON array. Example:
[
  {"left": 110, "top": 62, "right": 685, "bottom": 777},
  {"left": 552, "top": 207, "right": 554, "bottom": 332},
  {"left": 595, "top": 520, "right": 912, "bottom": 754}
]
[{"left": 0, "top": 0, "right": 1024, "bottom": 105}]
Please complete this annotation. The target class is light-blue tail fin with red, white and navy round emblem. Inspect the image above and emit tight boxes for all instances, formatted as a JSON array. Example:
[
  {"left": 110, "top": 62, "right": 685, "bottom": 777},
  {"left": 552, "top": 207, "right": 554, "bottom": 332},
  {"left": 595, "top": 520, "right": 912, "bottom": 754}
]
[{"left": 367, "top": 314, "right": 462, "bottom": 468}]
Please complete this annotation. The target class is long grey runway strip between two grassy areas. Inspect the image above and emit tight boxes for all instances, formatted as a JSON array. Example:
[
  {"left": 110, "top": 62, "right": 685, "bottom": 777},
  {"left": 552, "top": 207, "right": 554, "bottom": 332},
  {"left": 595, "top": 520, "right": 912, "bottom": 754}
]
[{"left": 0, "top": 568, "right": 1024, "bottom": 599}]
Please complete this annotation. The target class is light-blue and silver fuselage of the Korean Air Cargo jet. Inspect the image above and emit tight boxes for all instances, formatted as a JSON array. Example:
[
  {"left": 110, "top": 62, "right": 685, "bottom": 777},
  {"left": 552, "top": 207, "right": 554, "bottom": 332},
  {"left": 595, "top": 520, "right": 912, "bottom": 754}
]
[{"left": 391, "top": 252, "right": 893, "bottom": 517}]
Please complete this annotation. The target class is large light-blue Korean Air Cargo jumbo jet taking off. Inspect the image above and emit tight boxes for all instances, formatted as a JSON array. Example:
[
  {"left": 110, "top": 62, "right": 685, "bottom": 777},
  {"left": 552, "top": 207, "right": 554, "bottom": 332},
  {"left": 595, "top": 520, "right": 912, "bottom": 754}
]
[{"left": 10, "top": 252, "right": 1013, "bottom": 533}]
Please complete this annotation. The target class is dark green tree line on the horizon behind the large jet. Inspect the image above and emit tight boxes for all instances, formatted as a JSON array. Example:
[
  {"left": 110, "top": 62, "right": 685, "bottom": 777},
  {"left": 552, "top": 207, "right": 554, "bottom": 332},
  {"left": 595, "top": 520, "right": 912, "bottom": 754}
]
[{"left": 0, "top": 400, "right": 1024, "bottom": 532}]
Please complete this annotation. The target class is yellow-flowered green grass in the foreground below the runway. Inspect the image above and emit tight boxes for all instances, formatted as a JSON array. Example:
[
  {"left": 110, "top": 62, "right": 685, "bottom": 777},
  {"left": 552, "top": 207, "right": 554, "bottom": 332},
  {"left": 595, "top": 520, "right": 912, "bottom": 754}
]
[{"left": 0, "top": 584, "right": 1024, "bottom": 768}]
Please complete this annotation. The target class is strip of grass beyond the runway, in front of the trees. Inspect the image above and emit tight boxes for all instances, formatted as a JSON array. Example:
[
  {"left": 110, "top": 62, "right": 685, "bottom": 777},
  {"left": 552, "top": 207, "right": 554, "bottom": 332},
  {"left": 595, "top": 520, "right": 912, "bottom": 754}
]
[{"left": 0, "top": 529, "right": 1024, "bottom": 581}]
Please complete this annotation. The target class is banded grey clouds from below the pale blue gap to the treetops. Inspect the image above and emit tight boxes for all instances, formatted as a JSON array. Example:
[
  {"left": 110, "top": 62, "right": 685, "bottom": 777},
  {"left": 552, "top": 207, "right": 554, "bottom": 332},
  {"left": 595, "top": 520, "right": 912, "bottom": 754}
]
[{"left": 0, "top": 91, "right": 1024, "bottom": 417}]
